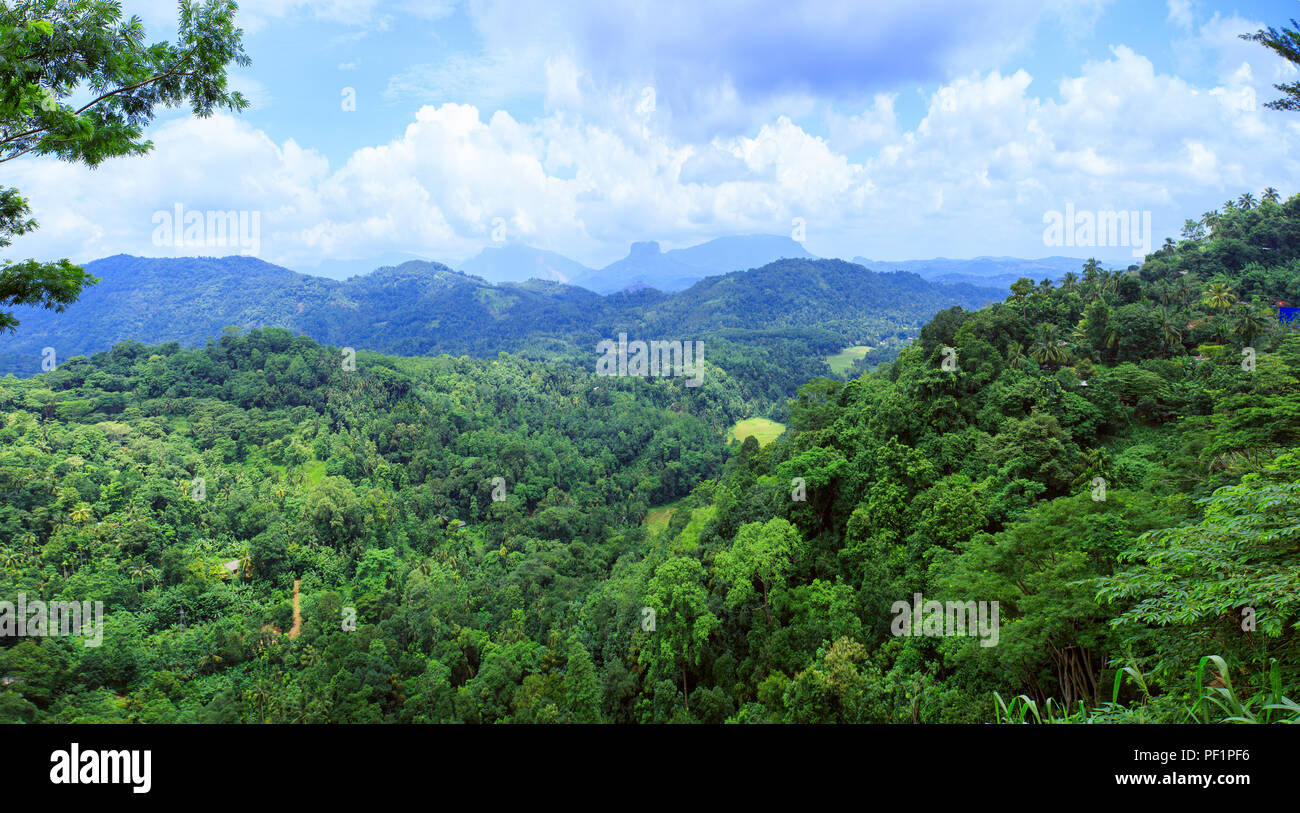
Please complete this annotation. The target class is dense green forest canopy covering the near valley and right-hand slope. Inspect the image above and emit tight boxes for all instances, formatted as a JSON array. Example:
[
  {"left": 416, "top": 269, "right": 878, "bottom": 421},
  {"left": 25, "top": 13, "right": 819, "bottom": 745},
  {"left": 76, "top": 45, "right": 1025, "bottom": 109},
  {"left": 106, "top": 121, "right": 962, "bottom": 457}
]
[{"left": 0, "top": 194, "right": 1300, "bottom": 722}]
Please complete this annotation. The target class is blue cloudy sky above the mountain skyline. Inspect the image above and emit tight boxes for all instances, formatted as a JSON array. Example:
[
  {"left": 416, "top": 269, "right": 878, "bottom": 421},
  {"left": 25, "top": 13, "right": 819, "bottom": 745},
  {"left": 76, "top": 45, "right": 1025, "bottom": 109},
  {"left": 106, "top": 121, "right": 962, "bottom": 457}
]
[{"left": 10, "top": 0, "right": 1300, "bottom": 272}]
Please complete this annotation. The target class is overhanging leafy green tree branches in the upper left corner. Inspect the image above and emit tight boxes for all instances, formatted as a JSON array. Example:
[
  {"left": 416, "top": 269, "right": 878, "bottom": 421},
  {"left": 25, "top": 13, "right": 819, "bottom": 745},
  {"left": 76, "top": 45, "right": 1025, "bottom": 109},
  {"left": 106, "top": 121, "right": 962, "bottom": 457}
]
[{"left": 0, "top": 0, "right": 250, "bottom": 332}]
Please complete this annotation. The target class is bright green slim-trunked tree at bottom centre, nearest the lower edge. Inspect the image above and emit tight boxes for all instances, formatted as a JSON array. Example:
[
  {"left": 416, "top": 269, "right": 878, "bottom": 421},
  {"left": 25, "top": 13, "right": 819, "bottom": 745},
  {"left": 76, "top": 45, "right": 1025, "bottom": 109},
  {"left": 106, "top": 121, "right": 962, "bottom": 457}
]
[{"left": 646, "top": 557, "right": 719, "bottom": 709}]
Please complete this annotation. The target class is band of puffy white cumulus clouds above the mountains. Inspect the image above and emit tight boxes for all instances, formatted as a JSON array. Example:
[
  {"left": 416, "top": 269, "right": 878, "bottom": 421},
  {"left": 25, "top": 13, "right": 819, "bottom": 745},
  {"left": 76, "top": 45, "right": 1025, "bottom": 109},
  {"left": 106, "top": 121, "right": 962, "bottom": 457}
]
[{"left": 10, "top": 7, "right": 1300, "bottom": 267}]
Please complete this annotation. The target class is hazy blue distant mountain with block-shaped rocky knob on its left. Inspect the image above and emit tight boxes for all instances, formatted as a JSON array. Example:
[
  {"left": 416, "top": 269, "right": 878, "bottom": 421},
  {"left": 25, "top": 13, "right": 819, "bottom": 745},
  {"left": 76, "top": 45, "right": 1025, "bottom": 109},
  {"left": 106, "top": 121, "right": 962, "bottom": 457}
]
[{"left": 572, "top": 234, "right": 813, "bottom": 294}]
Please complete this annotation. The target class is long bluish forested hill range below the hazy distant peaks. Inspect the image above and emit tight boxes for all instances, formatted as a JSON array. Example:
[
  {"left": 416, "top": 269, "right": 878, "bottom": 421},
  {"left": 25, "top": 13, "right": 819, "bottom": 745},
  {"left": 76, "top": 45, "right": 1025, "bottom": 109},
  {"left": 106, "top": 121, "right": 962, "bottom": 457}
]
[{"left": 0, "top": 255, "right": 1001, "bottom": 381}]
